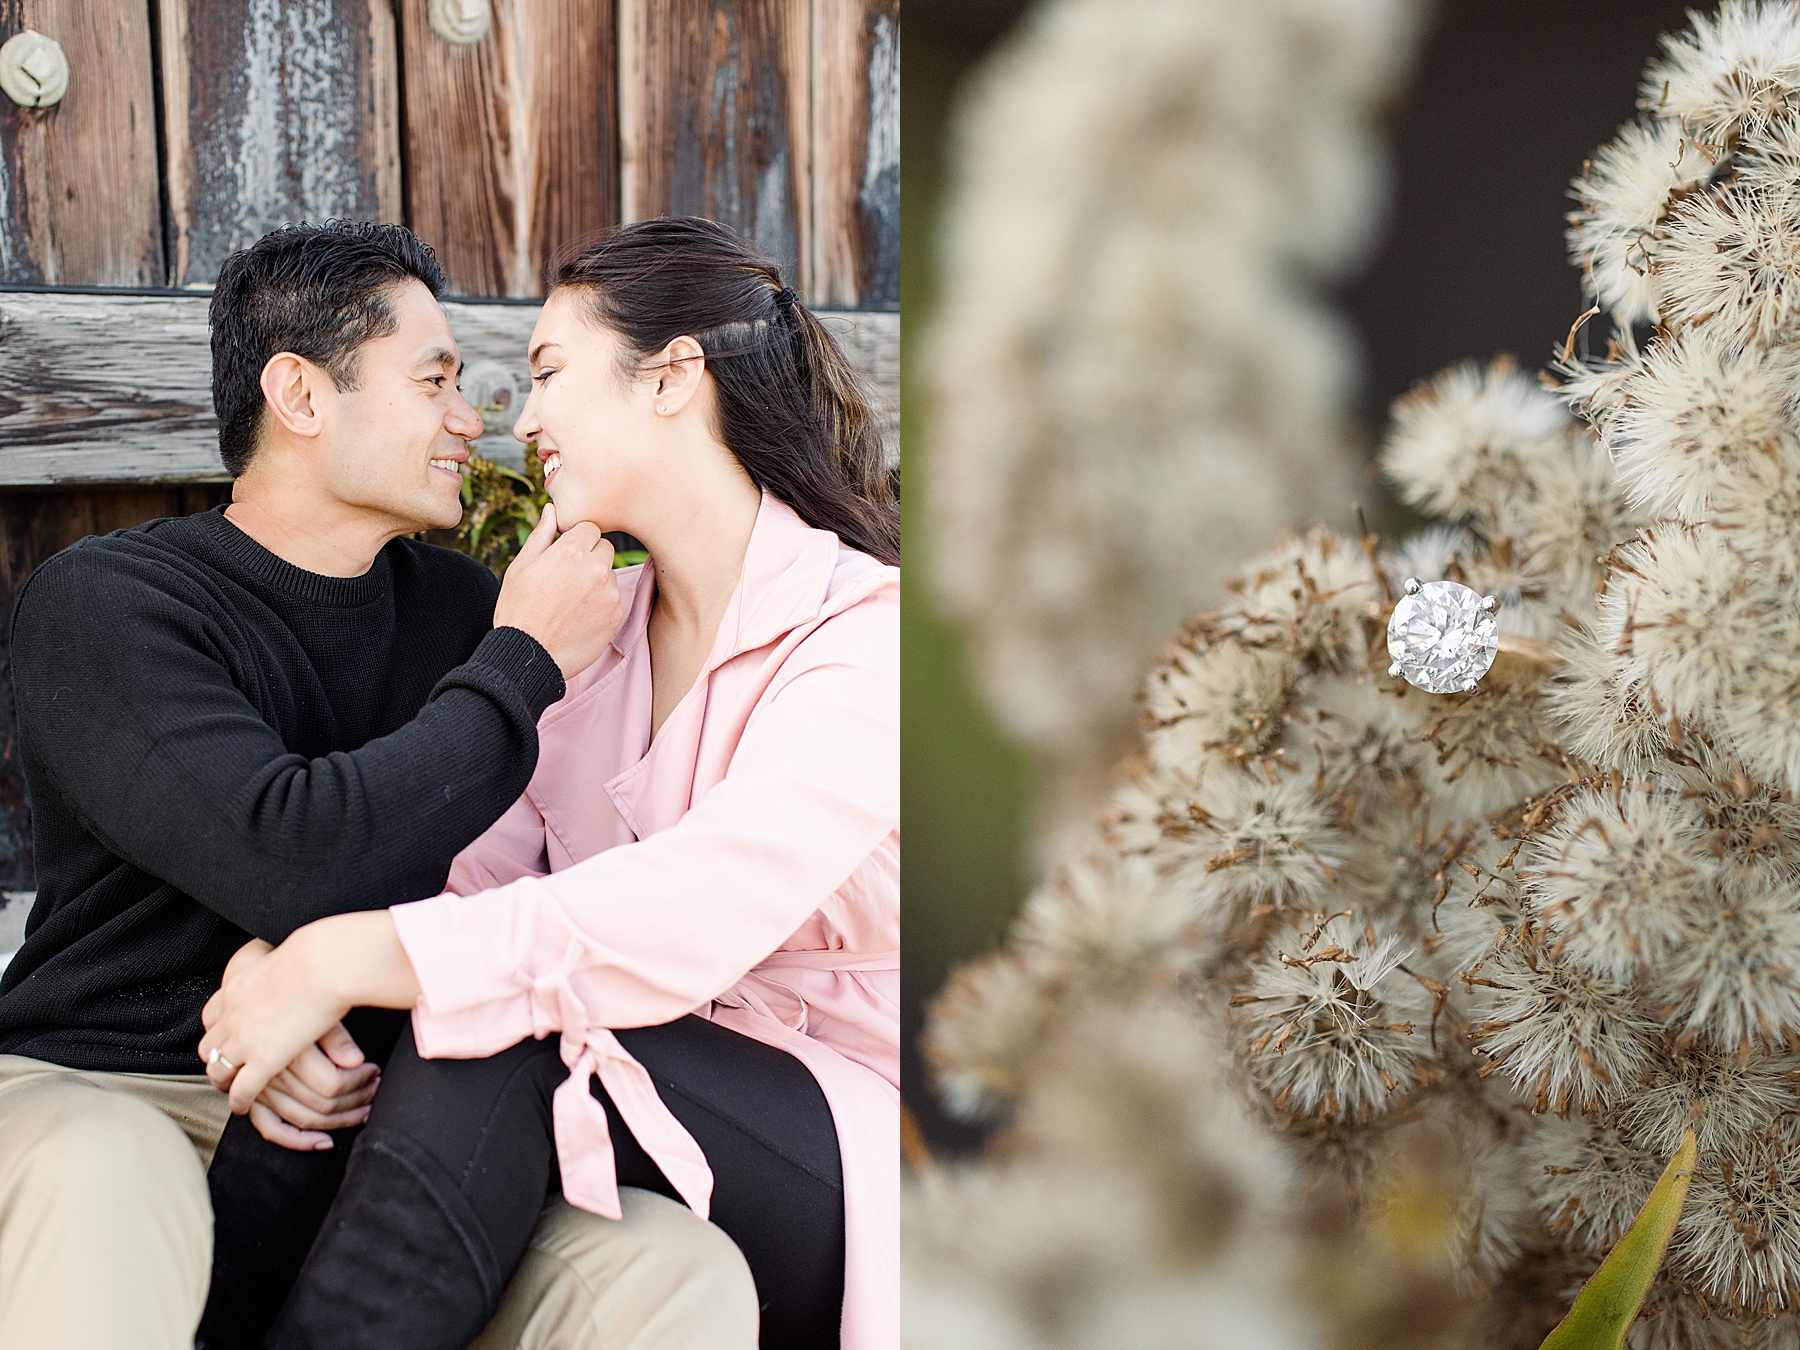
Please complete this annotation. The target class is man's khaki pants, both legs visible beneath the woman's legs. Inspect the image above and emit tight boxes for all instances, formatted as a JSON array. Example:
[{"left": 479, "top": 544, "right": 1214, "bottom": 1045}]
[{"left": 0, "top": 1055, "right": 756, "bottom": 1350}]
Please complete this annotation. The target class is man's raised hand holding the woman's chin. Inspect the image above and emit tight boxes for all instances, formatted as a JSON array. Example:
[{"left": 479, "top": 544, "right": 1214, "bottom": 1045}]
[{"left": 493, "top": 506, "right": 625, "bottom": 680}]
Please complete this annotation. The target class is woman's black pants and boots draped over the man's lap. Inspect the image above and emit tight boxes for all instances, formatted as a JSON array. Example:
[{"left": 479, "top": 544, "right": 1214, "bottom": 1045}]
[{"left": 200, "top": 1010, "right": 844, "bottom": 1350}]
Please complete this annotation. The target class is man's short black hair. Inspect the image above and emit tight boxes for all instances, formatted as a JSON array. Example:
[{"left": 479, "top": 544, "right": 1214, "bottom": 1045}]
[{"left": 209, "top": 220, "right": 445, "bottom": 479}]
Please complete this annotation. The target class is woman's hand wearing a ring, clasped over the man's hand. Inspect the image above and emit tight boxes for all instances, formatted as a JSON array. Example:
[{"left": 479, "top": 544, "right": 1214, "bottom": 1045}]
[{"left": 200, "top": 909, "right": 419, "bottom": 1116}]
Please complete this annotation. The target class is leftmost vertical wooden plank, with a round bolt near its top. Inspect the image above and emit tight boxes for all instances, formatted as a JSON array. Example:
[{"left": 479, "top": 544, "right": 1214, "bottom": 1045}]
[{"left": 0, "top": 0, "right": 164, "bottom": 286}]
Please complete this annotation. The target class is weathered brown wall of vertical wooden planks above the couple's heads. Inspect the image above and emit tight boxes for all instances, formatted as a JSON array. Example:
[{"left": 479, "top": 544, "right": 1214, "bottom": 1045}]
[{"left": 0, "top": 0, "right": 900, "bottom": 310}]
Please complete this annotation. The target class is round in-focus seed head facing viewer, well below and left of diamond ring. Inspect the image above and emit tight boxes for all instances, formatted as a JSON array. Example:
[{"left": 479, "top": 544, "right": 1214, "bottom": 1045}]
[{"left": 1231, "top": 914, "right": 1436, "bottom": 1123}]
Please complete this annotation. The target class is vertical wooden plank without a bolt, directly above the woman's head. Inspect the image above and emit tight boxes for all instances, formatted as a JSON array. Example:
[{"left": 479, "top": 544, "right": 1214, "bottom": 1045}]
[{"left": 619, "top": 0, "right": 812, "bottom": 292}]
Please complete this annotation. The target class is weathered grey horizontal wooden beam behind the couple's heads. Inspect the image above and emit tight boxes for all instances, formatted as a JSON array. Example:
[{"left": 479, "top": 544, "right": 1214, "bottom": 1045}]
[{"left": 0, "top": 290, "right": 900, "bottom": 488}]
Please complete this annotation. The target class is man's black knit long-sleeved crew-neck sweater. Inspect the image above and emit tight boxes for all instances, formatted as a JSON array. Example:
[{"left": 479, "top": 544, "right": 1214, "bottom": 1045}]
[{"left": 0, "top": 508, "right": 563, "bottom": 1073}]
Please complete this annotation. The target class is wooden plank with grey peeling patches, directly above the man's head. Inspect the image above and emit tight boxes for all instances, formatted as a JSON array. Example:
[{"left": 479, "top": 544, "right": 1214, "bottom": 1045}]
[{"left": 158, "top": 0, "right": 403, "bottom": 286}]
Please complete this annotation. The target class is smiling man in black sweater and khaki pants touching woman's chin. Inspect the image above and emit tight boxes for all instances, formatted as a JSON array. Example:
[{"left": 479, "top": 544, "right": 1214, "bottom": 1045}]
[{"left": 0, "top": 223, "right": 754, "bottom": 1350}]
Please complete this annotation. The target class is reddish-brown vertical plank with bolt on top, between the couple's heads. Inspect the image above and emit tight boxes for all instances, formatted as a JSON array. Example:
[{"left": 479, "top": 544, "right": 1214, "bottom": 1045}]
[{"left": 401, "top": 0, "right": 619, "bottom": 295}]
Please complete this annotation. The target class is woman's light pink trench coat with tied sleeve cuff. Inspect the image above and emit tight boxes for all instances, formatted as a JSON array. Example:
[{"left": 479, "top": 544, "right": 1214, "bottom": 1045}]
[{"left": 392, "top": 493, "right": 900, "bottom": 1350}]
